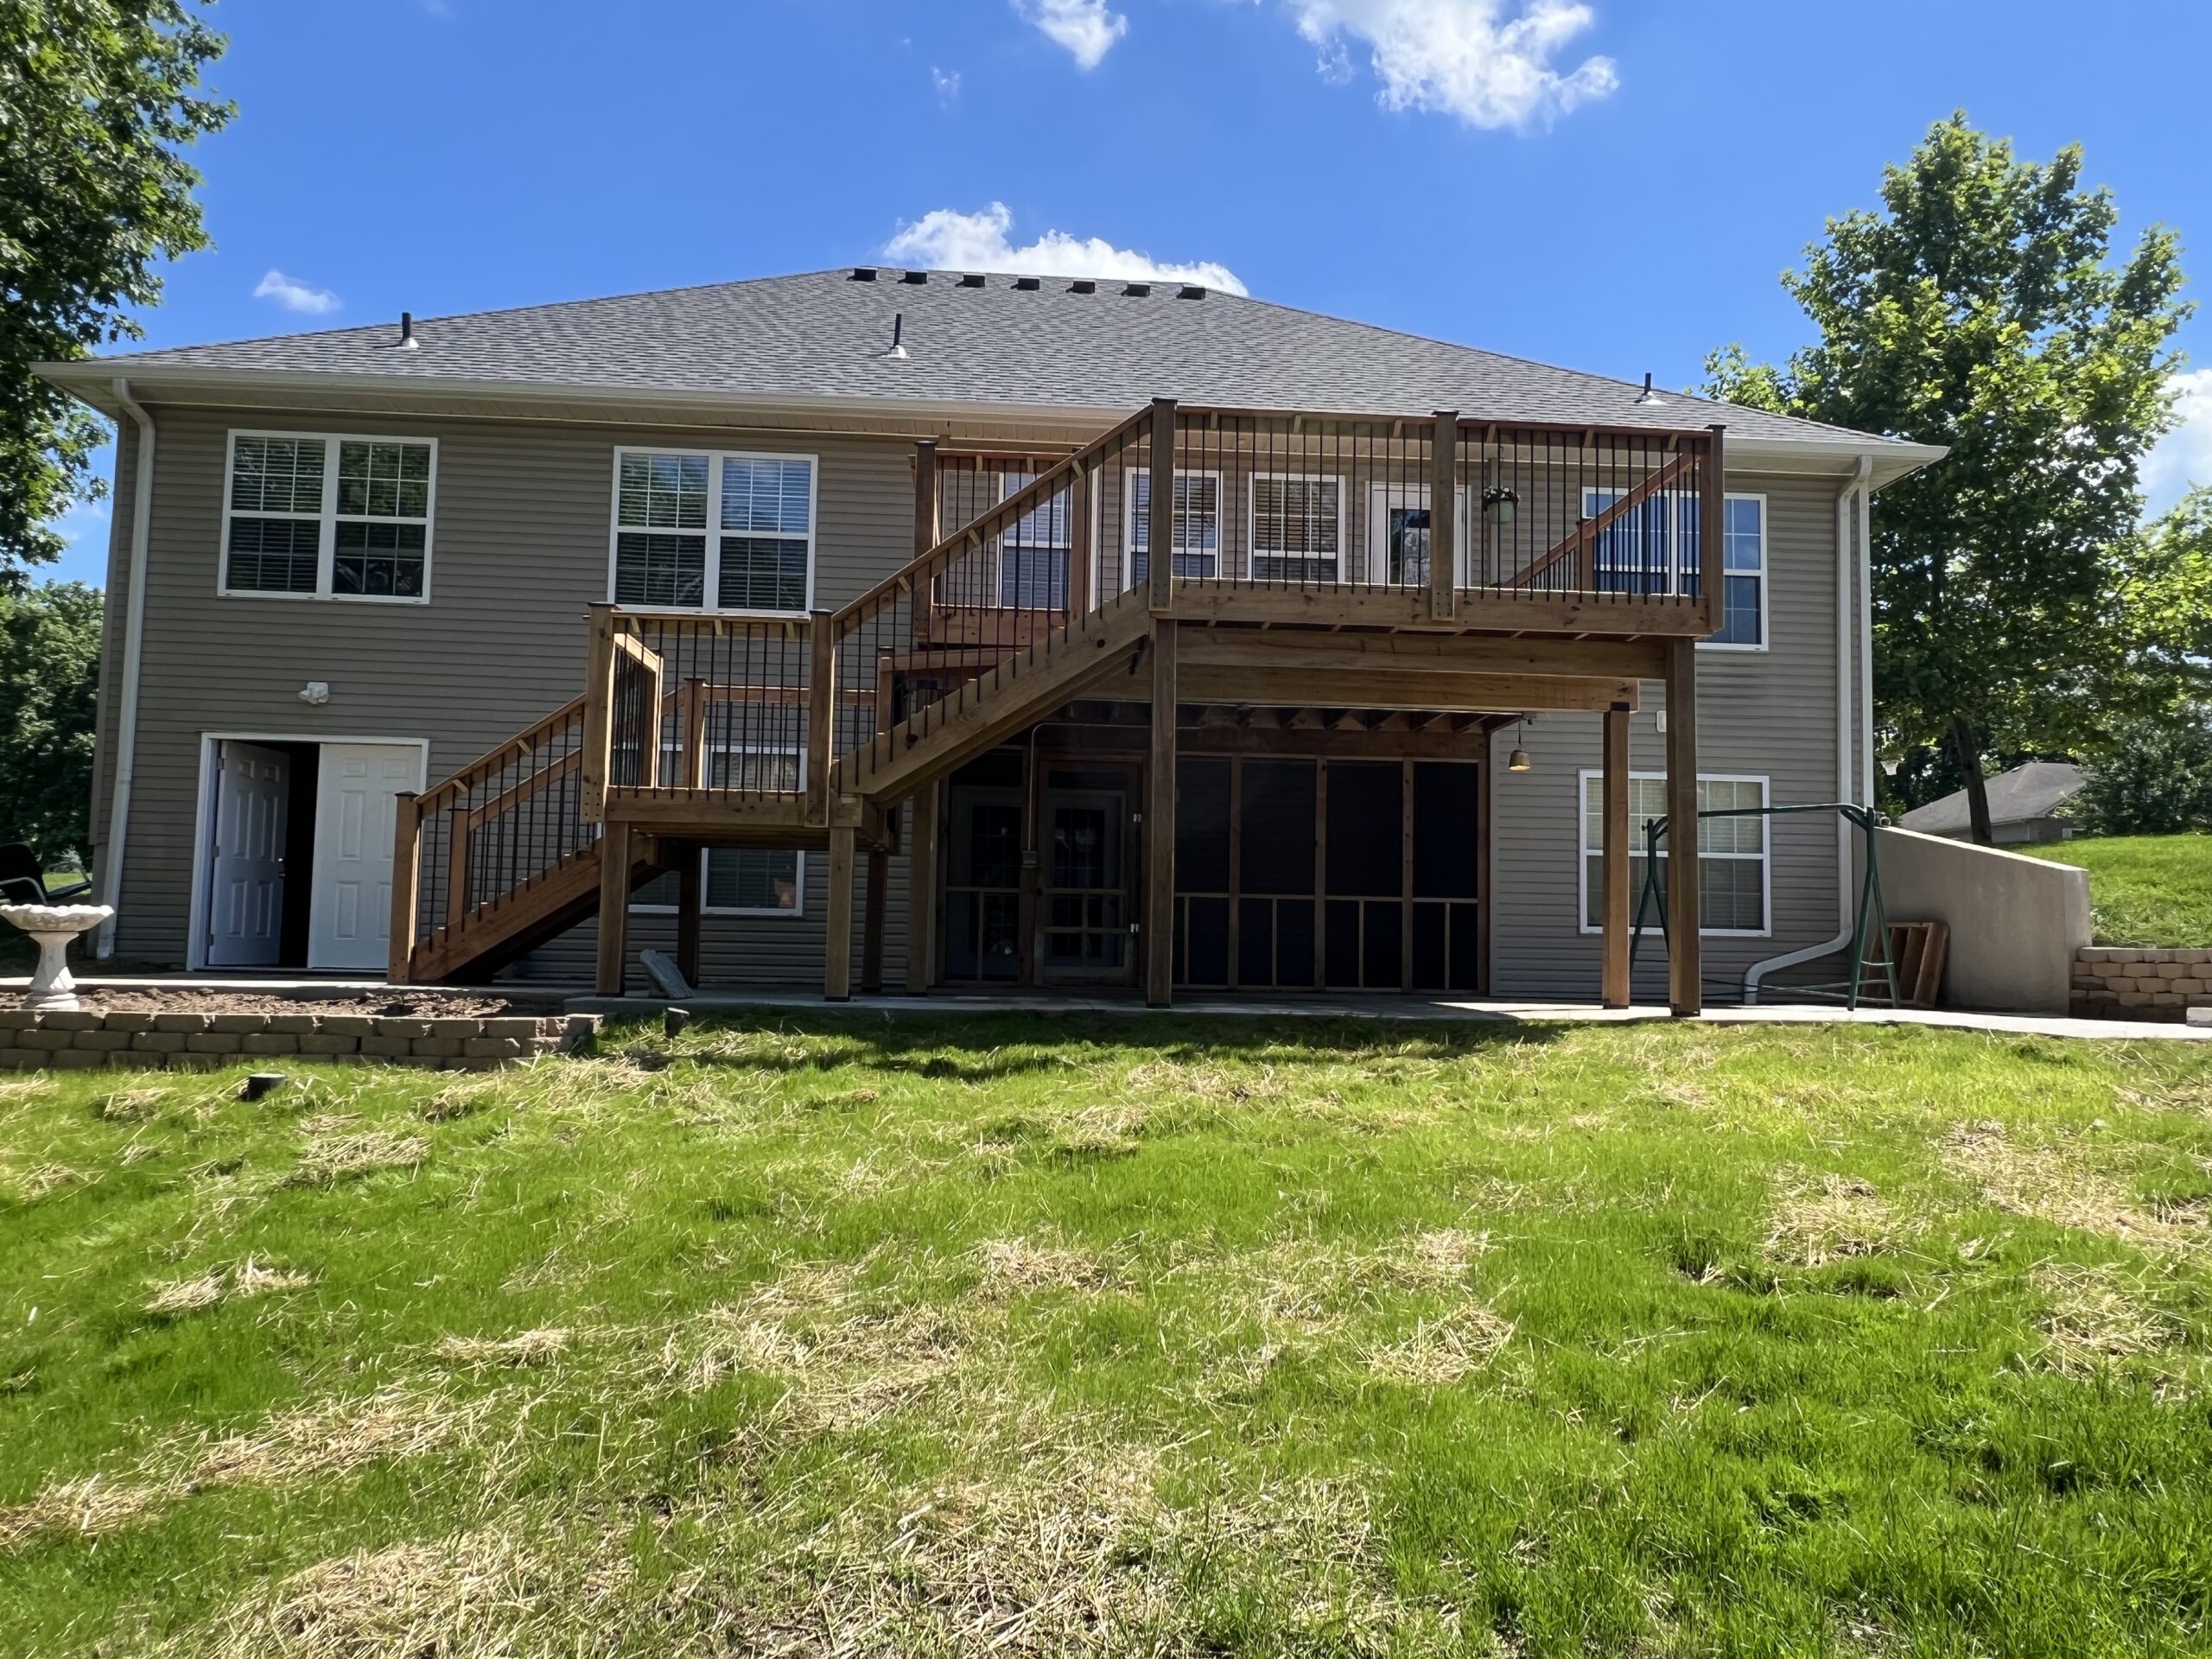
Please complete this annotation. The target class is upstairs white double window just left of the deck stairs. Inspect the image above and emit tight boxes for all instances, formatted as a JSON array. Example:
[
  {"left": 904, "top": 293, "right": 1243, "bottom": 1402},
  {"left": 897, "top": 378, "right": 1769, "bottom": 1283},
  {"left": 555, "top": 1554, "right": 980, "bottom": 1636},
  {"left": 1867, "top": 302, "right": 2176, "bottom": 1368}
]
[{"left": 608, "top": 449, "right": 814, "bottom": 615}]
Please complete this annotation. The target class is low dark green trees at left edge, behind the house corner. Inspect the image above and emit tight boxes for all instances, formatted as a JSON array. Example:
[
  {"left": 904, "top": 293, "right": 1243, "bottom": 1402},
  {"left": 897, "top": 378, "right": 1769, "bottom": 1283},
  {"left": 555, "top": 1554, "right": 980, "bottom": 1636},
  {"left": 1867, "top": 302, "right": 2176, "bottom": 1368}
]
[{"left": 0, "top": 582, "right": 102, "bottom": 858}]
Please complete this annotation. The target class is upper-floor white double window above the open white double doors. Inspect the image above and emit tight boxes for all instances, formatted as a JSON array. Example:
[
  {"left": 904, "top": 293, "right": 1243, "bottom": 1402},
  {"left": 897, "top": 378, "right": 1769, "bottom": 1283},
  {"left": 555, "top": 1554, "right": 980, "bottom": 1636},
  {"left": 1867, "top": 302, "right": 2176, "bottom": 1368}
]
[{"left": 219, "top": 431, "right": 438, "bottom": 604}]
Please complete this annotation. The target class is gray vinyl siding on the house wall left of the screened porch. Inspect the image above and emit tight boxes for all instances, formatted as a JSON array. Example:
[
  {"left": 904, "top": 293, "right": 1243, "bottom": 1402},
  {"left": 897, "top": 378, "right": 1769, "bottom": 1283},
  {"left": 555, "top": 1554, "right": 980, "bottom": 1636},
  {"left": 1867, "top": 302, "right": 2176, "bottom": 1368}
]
[{"left": 102, "top": 407, "right": 913, "bottom": 982}]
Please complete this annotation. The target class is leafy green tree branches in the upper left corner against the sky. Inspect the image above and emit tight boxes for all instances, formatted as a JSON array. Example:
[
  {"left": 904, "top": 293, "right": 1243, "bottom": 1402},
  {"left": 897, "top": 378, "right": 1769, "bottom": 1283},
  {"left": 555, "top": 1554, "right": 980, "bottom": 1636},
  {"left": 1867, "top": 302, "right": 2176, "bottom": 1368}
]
[{"left": 0, "top": 0, "right": 232, "bottom": 588}]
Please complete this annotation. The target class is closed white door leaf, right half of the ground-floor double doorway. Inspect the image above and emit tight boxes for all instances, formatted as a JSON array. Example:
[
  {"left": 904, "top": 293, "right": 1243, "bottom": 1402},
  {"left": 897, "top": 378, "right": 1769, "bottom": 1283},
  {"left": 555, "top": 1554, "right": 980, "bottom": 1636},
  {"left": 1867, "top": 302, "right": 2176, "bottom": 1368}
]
[{"left": 308, "top": 743, "right": 423, "bottom": 976}]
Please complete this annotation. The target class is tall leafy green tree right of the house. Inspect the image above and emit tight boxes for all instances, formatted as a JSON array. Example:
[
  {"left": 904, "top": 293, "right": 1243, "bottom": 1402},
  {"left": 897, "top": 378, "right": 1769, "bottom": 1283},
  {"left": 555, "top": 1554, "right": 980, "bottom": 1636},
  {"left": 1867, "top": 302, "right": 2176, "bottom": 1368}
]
[{"left": 1706, "top": 113, "right": 2199, "bottom": 842}]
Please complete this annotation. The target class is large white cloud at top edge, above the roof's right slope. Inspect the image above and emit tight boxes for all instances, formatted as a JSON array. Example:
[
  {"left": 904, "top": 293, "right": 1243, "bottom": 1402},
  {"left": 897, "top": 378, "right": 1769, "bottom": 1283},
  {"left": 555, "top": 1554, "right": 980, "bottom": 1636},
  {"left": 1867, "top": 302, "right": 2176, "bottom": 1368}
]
[{"left": 1287, "top": 0, "right": 1619, "bottom": 126}]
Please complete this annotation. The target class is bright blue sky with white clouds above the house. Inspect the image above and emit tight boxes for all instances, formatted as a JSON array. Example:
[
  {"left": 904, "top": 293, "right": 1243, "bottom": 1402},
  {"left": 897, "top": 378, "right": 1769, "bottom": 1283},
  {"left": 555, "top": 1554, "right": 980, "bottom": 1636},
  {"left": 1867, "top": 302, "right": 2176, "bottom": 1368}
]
[{"left": 35, "top": 0, "right": 2212, "bottom": 582}]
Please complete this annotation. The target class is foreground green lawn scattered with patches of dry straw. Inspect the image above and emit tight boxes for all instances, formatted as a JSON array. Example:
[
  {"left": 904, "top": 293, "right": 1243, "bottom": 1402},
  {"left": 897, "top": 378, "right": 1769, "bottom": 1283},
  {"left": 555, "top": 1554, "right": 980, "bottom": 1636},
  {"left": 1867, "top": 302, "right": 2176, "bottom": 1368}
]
[{"left": 0, "top": 1015, "right": 2212, "bottom": 1659}]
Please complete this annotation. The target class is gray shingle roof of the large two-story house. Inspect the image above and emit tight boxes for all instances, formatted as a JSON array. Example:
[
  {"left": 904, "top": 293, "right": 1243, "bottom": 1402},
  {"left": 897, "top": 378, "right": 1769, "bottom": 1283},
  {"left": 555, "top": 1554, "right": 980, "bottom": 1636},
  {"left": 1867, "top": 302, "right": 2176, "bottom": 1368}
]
[{"left": 81, "top": 268, "right": 1913, "bottom": 451}]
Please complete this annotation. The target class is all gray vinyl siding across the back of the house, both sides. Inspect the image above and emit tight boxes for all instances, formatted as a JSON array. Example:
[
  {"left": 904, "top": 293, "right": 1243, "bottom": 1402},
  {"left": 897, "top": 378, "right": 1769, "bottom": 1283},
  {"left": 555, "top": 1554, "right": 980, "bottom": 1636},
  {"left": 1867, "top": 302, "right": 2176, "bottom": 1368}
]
[{"left": 98, "top": 407, "right": 1866, "bottom": 1000}]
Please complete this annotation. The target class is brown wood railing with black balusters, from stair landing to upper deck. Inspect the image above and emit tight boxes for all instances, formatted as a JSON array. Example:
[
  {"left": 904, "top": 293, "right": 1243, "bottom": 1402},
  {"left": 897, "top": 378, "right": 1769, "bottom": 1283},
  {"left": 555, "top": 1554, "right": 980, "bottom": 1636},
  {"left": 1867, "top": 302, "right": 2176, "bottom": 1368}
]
[{"left": 582, "top": 400, "right": 1723, "bottom": 825}]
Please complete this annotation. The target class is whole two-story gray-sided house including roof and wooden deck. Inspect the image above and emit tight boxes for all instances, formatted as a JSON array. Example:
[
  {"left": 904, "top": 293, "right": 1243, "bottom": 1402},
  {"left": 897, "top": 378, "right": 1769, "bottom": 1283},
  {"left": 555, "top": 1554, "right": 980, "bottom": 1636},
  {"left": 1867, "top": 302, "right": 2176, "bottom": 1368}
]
[{"left": 40, "top": 265, "right": 1940, "bottom": 1008}]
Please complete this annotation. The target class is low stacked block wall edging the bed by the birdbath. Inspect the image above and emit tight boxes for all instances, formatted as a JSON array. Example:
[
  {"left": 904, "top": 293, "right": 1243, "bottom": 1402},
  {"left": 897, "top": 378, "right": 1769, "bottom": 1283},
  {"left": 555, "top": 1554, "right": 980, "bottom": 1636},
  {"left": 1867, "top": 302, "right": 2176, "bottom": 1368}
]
[{"left": 0, "top": 1008, "right": 600, "bottom": 1071}]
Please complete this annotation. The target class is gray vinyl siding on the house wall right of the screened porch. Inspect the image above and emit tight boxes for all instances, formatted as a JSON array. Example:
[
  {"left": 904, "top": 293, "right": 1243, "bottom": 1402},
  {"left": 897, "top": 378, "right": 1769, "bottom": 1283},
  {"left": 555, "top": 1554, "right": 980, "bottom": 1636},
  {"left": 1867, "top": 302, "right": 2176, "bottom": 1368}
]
[{"left": 1491, "top": 475, "right": 1856, "bottom": 1002}]
